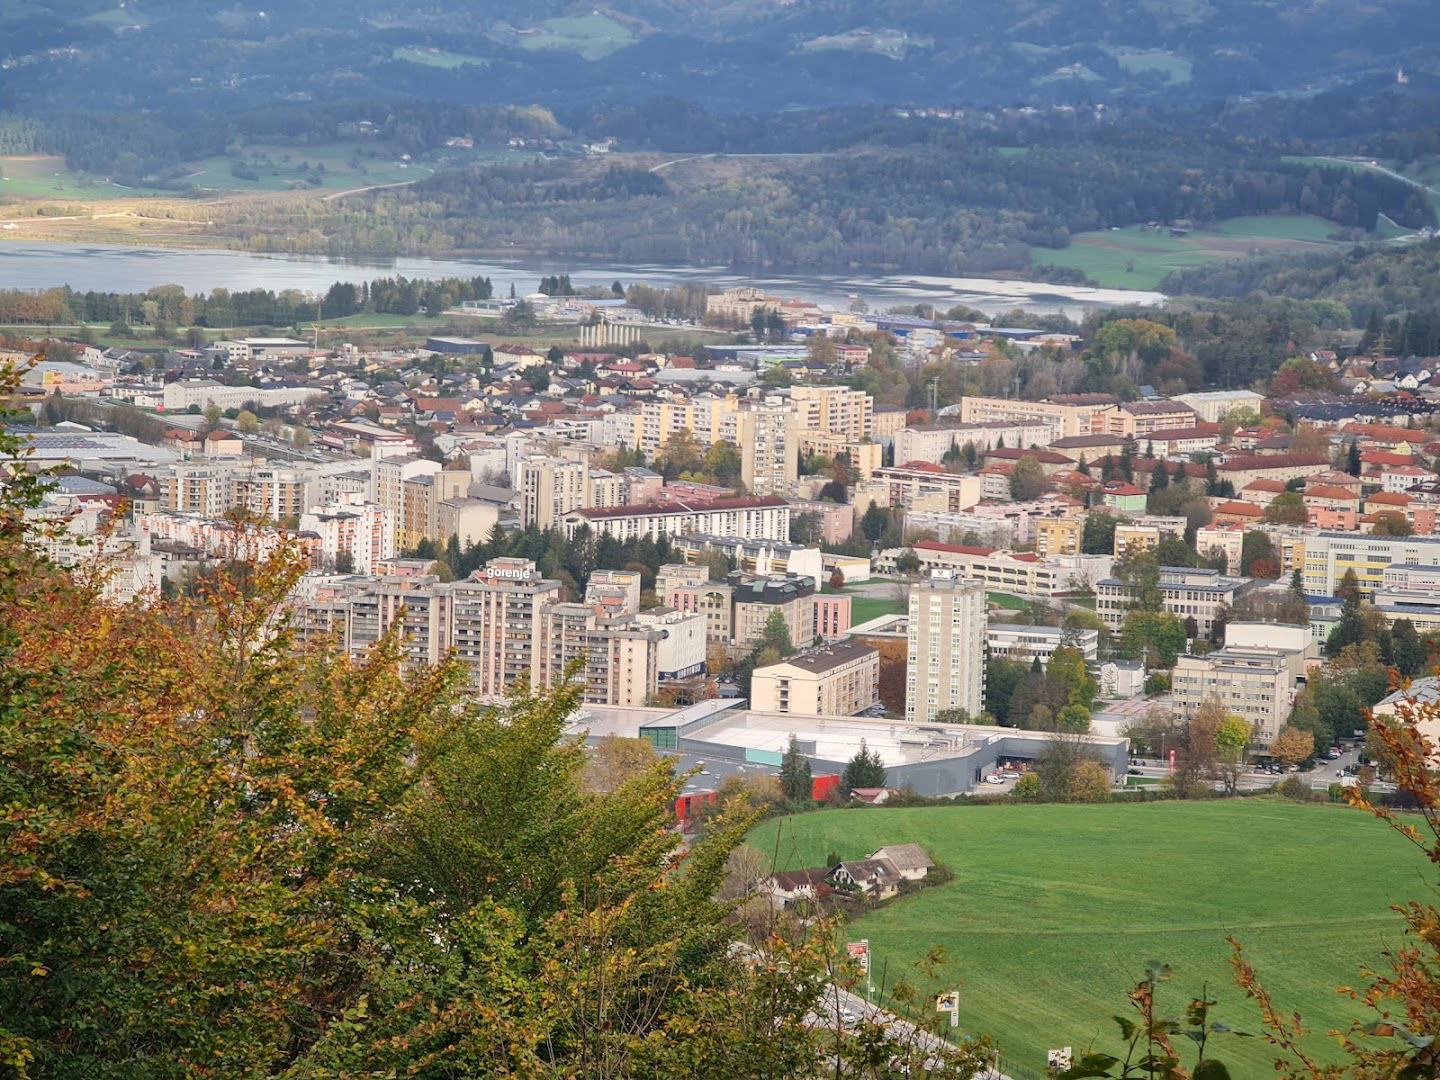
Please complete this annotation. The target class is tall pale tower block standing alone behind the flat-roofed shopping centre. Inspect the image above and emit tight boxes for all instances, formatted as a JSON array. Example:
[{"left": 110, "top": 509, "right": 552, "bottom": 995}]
[{"left": 904, "top": 570, "right": 985, "bottom": 723}]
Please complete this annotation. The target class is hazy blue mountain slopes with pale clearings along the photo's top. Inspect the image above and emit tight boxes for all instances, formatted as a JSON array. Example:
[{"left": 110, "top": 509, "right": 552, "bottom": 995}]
[{"left": 0, "top": 0, "right": 1440, "bottom": 112}]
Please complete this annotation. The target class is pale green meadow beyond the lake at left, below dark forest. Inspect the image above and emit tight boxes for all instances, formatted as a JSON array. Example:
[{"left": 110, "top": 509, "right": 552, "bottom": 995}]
[{"left": 184, "top": 143, "right": 433, "bottom": 192}]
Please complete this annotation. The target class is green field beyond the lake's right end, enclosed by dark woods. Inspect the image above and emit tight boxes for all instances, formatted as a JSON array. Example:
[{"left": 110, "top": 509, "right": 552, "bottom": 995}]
[{"left": 1030, "top": 213, "right": 1338, "bottom": 289}]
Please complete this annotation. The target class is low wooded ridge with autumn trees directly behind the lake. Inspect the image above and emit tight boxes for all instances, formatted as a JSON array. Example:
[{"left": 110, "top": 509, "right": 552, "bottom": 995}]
[{"left": 224, "top": 137, "right": 1434, "bottom": 274}]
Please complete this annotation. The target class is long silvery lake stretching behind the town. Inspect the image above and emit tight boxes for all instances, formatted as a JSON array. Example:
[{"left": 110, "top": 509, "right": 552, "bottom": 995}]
[{"left": 0, "top": 239, "right": 1165, "bottom": 317}]
